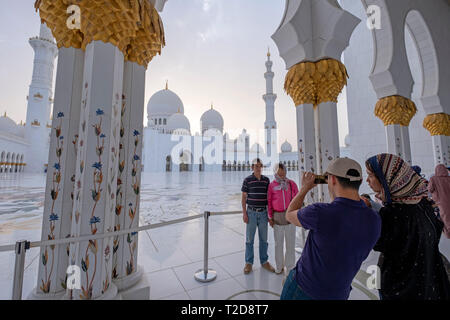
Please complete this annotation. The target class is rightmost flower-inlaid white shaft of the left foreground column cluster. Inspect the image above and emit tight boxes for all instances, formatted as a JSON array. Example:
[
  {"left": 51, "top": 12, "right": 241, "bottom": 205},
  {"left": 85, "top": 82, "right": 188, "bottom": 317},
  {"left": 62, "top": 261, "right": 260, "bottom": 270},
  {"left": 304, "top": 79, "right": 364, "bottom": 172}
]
[{"left": 112, "top": 61, "right": 146, "bottom": 290}]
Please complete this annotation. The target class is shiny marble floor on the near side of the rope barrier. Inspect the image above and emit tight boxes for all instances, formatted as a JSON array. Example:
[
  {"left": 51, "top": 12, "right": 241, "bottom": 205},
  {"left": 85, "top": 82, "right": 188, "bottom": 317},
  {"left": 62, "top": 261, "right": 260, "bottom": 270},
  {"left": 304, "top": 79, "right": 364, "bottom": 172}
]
[{"left": 0, "top": 215, "right": 450, "bottom": 300}]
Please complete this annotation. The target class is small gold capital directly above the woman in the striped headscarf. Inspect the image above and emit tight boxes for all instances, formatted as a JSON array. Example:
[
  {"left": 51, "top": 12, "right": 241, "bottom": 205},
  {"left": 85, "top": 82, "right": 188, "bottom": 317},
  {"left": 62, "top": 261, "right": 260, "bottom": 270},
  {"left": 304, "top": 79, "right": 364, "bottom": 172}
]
[{"left": 375, "top": 95, "right": 417, "bottom": 127}]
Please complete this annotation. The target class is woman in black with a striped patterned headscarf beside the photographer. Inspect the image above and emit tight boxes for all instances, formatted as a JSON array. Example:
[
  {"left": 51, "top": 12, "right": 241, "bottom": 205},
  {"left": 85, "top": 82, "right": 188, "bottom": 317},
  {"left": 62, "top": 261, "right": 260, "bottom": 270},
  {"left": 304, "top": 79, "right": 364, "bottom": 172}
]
[{"left": 366, "top": 154, "right": 450, "bottom": 300}]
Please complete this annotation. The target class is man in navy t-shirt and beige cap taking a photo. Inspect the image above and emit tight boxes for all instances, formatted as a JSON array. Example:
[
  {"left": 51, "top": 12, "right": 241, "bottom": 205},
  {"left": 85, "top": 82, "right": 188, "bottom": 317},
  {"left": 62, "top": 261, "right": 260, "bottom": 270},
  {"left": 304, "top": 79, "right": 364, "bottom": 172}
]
[{"left": 281, "top": 158, "right": 381, "bottom": 300}]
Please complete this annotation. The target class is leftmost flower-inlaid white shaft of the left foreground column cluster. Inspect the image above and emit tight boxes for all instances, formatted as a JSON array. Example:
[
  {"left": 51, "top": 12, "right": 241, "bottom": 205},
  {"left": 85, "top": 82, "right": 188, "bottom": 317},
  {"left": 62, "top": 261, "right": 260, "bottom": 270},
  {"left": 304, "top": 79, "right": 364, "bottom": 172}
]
[{"left": 29, "top": 48, "right": 84, "bottom": 299}]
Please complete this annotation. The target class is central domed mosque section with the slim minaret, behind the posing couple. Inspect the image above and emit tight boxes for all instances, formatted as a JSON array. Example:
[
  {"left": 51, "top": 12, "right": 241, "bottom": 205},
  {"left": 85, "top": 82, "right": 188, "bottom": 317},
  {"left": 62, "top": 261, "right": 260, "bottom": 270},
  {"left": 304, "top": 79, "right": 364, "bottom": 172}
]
[{"left": 139, "top": 53, "right": 298, "bottom": 172}]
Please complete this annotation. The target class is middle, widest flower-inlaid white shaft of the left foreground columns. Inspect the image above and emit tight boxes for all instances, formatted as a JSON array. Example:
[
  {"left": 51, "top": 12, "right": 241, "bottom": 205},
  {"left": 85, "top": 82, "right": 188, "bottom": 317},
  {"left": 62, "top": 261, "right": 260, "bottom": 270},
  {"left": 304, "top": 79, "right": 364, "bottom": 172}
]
[{"left": 67, "top": 41, "right": 124, "bottom": 299}]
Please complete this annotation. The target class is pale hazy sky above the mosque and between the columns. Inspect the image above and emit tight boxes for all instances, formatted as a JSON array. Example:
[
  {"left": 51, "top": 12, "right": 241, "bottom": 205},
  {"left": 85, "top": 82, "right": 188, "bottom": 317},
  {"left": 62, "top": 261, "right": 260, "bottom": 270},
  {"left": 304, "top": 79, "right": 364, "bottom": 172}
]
[{"left": 0, "top": 0, "right": 348, "bottom": 148}]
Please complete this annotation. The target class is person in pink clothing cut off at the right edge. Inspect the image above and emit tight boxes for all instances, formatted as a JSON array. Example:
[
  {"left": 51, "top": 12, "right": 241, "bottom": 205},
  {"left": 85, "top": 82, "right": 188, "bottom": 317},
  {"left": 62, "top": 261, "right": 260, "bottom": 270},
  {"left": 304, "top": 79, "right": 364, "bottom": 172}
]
[{"left": 428, "top": 164, "right": 450, "bottom": 239}]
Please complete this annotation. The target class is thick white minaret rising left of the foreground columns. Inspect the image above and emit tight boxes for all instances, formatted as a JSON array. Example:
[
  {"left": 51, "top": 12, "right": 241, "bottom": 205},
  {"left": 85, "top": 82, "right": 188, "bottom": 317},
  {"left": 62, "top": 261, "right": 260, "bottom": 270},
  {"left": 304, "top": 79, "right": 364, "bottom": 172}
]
[{"left": 25, "top": 24, "right": 58, "bottom": 173}]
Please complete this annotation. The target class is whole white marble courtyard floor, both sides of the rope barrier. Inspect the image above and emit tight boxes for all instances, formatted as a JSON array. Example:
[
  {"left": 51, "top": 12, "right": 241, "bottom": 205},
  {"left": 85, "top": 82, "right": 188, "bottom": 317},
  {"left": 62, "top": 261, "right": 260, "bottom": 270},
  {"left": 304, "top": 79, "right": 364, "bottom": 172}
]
[{"left": 0, "top": 173, "right": 450, "bottom": 300}]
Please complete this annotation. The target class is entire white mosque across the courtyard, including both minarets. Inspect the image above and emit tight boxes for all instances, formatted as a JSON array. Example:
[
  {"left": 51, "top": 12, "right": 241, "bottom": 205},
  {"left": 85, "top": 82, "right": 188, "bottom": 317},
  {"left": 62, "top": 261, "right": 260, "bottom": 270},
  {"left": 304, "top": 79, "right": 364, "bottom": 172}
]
[{"left": 0, "top": 24, "right": 299, "bottom": 173}]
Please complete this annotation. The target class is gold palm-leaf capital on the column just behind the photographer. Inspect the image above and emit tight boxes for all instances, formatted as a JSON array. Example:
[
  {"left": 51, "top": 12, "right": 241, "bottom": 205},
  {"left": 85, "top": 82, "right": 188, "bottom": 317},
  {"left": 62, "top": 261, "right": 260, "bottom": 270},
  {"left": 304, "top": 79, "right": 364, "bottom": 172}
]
[{"left": 284, "top": 59, "right": 348, "bottom": 107}]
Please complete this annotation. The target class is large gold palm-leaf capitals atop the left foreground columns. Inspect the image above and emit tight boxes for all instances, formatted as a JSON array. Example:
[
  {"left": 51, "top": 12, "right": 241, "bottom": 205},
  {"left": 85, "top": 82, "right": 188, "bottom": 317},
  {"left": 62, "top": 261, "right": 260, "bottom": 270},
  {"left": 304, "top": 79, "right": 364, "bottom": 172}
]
[{"left": 35, "top": 0, "right": 165, "bottom": 67}]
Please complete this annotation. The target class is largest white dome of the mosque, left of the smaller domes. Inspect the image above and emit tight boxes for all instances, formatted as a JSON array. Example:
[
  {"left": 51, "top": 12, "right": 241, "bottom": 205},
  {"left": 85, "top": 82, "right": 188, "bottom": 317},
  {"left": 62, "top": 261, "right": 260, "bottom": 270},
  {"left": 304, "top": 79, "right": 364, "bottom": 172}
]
[{"left": 147, "top": 89, "right": 184, "bottom": 118}]
